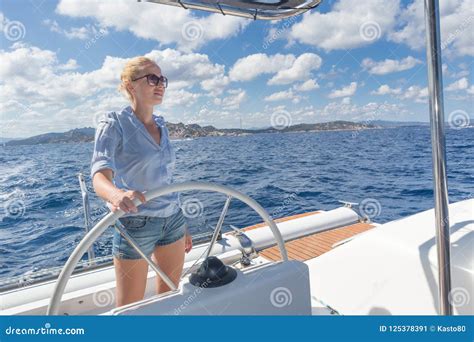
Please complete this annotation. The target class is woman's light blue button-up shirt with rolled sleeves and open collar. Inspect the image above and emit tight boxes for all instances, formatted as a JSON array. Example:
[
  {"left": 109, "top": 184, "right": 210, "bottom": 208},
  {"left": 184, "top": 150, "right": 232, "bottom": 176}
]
[{"left": 91, "top": 106, "right": 181, "bottom": 217}]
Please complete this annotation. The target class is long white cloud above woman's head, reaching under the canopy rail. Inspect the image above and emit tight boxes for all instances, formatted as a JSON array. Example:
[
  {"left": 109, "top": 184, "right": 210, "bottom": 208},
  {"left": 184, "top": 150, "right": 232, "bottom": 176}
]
[{"left": 56, "top": 0, "right": 251, "bottom": 52}]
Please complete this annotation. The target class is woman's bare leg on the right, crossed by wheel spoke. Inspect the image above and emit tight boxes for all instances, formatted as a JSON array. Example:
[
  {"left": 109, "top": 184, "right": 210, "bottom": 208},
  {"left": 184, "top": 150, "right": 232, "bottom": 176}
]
[{"left": 153, "top": 237, "right": 185, "bottom": 294}]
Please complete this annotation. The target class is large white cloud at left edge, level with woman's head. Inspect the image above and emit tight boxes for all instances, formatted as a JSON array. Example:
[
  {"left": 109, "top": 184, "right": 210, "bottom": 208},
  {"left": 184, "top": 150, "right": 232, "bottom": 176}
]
[{"left": 0, "top": 43, "right": 125, "bottom": 106}]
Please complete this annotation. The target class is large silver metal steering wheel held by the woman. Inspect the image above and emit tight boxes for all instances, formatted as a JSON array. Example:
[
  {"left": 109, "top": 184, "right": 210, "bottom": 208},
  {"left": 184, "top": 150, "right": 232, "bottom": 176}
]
[{"left": 47, "top": 182, "right": 288, "bottom": 315}]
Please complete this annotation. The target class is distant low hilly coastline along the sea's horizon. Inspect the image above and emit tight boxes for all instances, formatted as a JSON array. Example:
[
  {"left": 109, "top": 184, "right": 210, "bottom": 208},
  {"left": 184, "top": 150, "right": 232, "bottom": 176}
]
[{"left": 0, "top": 120, "right": 427, "bottom": 146}]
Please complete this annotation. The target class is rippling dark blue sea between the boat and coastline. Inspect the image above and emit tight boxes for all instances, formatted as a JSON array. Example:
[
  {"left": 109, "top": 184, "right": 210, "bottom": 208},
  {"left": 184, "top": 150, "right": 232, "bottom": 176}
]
[{"left": 0, "top": 126, "right": 474, "bottom": 278}]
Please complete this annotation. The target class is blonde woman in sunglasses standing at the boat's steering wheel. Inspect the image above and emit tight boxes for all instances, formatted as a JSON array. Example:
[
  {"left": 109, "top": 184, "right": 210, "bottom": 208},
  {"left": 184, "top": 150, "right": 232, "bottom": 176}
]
[{"left": 91, "top": 57, "right": 192, "bottom": 306}]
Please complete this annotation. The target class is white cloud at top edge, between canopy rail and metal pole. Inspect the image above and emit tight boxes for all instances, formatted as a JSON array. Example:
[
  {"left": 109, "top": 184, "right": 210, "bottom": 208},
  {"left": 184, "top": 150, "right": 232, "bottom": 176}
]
[{"left": 287, "top": 0, "right": 399, "bottom": 51}]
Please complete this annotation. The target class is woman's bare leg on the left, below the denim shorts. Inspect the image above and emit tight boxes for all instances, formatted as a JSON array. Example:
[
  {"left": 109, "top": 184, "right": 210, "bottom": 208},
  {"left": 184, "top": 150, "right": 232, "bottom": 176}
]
[{"left": 114, "top": 258, "right": 148, "bottom": 307}]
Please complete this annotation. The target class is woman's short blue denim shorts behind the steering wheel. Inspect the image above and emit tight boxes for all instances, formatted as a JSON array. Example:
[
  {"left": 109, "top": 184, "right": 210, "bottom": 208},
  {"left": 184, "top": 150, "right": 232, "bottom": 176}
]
[{"left": 112, "top": 209, "right": 187, "bottom": 259}]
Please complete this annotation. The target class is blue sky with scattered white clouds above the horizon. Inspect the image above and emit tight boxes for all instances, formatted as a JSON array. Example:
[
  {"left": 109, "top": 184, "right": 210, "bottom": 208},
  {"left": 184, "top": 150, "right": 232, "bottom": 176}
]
[{"left": 0, "top": 0, "right": 474, "bottom": 138}]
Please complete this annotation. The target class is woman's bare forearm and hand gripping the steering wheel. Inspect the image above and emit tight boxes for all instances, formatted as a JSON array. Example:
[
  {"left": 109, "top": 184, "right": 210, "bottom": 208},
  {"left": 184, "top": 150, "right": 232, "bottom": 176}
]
[{"left": 92, "top": 169, "right": 145, "bottom": 213}]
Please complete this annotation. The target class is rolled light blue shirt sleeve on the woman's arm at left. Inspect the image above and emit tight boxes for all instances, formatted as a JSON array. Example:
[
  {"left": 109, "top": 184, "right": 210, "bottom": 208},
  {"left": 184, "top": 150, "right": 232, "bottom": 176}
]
[{"left": 91, "top": 113, "right": 121, "bottom": 179}]
